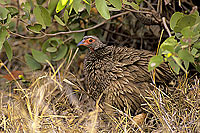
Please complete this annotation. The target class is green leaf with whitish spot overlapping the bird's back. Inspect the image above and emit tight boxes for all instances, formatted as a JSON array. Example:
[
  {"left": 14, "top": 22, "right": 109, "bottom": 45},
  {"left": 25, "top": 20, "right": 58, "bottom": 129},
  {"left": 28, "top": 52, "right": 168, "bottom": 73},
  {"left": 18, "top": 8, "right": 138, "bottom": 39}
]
[{"left": 148, "top": 55, "right": 163, "bottom": 71}]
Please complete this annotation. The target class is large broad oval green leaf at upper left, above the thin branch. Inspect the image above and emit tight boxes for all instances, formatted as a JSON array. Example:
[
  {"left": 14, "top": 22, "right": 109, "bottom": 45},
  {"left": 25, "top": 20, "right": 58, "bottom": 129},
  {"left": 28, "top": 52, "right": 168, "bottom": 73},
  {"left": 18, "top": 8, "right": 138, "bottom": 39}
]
[{"left": 33, "top": 6, "right": 51, "bottom": 29}]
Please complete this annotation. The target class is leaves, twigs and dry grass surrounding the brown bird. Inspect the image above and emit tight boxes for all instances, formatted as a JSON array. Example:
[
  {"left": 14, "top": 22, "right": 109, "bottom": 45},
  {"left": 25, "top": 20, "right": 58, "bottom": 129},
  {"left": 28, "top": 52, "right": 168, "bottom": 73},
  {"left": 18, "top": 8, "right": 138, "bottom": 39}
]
[{"left": 0, "top": 0, "right": 200, "bottom": 133}]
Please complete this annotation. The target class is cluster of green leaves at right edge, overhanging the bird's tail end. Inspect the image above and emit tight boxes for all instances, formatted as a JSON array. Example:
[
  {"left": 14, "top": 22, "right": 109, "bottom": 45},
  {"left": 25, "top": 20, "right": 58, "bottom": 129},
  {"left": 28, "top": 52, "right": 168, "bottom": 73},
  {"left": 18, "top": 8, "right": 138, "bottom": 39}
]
[{"left": 148, "top": 11, "right": 200, "bottom": 74}]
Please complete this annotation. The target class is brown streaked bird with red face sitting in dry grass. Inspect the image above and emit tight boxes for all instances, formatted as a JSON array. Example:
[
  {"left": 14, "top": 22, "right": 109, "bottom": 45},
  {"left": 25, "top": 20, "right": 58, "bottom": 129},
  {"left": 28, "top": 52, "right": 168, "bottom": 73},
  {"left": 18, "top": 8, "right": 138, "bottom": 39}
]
[{"left": 77, "top": 36, "right": 173, "bottom": 112}]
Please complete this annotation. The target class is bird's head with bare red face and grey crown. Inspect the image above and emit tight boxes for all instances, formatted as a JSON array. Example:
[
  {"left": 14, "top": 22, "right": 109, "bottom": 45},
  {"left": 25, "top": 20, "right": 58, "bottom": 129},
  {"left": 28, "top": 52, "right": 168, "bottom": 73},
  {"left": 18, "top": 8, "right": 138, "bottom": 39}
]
[{"left": 77, "top": 36, "right": 106, "bottom": 51}]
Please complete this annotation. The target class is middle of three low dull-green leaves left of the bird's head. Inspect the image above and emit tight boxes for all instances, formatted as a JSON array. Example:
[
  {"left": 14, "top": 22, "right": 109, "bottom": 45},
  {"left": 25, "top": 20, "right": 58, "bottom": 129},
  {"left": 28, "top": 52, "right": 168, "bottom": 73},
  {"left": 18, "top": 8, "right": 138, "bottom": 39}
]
[{"left": 31, "top": 49, "right": 51, "bottom": 63}]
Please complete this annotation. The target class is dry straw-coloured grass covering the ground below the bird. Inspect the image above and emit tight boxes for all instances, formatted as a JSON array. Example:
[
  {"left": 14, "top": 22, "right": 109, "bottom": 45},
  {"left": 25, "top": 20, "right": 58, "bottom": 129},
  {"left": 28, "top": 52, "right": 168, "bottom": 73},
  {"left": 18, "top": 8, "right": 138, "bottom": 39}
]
[{"left": 0, "top": 50, "right": 200, "bottom": 133}]
